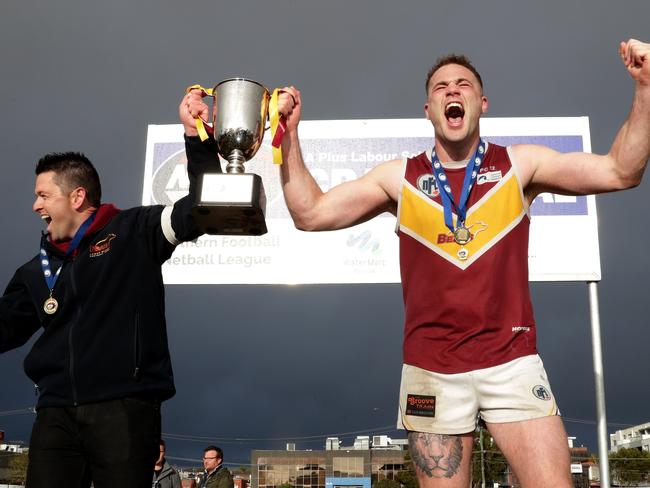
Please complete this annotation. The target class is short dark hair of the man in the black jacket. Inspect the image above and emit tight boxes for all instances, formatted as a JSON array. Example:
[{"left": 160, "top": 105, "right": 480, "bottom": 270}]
[{"left": 36, "top": 152, "right": 102, "bottom": 207}]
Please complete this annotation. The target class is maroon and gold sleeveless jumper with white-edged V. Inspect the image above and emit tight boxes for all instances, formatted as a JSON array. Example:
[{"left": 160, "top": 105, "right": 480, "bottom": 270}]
[{"left": 397, "top": 144, "right": 537, "bottom": 374}]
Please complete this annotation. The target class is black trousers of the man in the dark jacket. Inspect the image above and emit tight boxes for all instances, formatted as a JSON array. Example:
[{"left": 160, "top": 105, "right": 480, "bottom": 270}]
[{"left": 26, "top": 397, "right": 160, "bottom": 488}]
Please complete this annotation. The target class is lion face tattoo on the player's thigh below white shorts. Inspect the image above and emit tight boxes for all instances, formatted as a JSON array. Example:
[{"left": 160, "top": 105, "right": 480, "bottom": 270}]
[{"left": 409, "top": 432, "right": 463, "bottom": 478}]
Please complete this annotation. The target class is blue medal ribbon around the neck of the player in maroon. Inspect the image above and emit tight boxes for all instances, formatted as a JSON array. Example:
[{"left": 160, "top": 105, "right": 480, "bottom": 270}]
[{"left": 431, "top": 139, "right": 486, "bottom": 232}]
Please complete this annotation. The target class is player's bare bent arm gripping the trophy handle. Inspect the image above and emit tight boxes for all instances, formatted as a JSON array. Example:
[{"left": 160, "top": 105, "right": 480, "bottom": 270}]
[{"left": 279, "top": 87, "right": 401, "bottom": 231}]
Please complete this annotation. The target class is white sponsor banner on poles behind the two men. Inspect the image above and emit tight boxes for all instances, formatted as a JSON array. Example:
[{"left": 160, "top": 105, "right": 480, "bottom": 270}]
[{"left": 142, "top": 117, "right": 600, "bottom": 284}]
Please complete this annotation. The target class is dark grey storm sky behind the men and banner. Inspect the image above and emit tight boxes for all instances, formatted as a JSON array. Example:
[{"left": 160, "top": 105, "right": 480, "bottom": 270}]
[{"left": 0, "top": 0, "right": 650, "bottom": 464}]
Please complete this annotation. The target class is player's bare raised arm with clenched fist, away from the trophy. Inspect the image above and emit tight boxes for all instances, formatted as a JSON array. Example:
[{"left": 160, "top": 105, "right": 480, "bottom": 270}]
[{"left": 512, "top": 39, "right": 650, "bottom": 201}]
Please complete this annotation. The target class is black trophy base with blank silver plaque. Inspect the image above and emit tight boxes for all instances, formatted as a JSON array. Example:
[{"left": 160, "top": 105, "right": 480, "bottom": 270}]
[{"left": 192, "top": 173, "right": 268, "bottom": 236}]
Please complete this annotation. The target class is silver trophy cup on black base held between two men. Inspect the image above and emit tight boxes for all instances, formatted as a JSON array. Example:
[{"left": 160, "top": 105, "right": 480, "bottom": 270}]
[{"left": 192, "top": 78, "right": 271, "bottom": 235}]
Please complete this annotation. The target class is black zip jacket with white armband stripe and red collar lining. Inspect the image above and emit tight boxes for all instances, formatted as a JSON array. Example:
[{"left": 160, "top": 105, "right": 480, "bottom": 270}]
[{"left": 0, "top": 138, "right": 220, "bottom": 407}]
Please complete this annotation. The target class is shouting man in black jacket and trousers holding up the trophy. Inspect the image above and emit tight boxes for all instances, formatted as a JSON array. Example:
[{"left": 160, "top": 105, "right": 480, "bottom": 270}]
[{"left": 0, "top": 92, "right": 220, "bottom": 488}]
